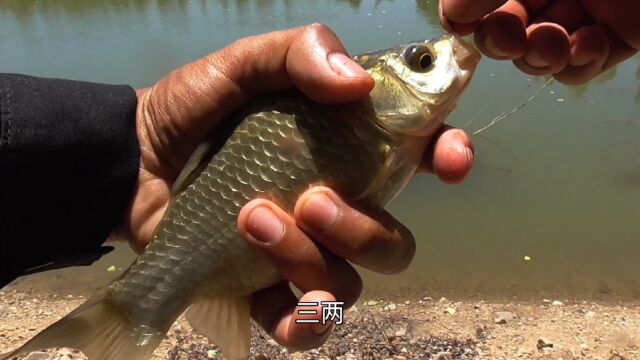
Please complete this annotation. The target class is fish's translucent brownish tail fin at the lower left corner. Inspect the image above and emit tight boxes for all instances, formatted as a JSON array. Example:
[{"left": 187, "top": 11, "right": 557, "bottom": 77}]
[{"left": 0, "top": 291, "right": 164, "bottom": 360}]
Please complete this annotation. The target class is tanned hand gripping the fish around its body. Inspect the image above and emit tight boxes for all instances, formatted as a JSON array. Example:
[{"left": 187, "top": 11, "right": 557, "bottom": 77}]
[{"left": 121, "top": 25, "right": 473, "bottom": 349}]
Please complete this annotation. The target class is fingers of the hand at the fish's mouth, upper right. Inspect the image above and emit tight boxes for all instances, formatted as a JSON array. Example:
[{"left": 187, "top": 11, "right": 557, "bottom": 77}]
[{"left": 440, "top": 0, "right": 640, "bottom": 85}]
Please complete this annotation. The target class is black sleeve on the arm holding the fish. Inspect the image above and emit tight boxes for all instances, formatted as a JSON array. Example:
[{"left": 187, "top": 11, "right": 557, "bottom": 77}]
[{"left": 0, "top": 74, "right": 140, "bottom": 287}]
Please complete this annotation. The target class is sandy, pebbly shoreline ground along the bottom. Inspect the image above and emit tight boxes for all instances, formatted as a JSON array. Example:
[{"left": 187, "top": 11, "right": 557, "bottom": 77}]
[{"left": 0, "top": 287, "right": 640, "bottom": 360}]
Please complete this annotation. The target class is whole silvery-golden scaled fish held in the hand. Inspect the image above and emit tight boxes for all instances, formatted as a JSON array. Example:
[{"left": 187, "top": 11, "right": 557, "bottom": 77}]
[{"left": 0, "top": 34, "right": 481, "bottom": 360}]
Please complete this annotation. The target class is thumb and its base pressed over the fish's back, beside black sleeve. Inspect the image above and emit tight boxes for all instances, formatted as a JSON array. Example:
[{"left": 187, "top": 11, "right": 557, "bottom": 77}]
[{"left": 141, "top": 24, "right": 374, "bottom": 160}]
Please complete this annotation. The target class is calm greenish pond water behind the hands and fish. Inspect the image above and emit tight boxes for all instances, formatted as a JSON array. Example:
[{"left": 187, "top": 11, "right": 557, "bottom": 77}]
[{"left": 0, "top": 0, "right": 640, "bottom": 297}]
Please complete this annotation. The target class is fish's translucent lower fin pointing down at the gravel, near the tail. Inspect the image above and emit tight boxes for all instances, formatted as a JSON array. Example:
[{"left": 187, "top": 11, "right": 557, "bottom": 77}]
[{"left": 185, "top": 297, "right": 251, "bottom": 360}]
